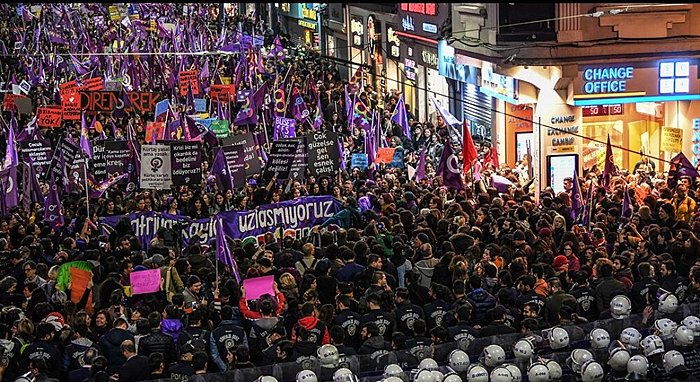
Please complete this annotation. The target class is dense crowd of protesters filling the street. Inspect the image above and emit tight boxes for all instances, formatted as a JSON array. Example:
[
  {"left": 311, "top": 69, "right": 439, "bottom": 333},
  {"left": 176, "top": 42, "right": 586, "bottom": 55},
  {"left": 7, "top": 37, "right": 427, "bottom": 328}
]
[{"left": 0, "top": 4, "right": 700, "bottom": 382}]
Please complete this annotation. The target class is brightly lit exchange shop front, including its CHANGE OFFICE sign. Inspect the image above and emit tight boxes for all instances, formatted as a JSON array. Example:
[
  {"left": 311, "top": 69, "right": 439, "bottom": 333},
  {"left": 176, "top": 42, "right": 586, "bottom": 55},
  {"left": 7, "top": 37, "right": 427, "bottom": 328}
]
[{"left": 572, "top": 59, "right": 700, "bottom": 175}]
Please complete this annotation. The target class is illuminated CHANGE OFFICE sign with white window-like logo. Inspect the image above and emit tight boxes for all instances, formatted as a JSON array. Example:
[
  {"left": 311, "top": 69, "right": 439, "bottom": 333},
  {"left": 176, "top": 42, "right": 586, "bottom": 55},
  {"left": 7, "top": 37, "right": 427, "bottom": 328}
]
[{"left": 573, "top": 59, "right": 700, "bottom": 106}]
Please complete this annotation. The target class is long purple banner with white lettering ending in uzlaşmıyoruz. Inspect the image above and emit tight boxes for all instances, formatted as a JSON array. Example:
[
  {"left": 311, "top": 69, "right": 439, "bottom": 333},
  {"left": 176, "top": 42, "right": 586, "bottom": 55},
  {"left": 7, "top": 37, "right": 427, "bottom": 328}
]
[{"left": 100, "top": 196, "right": 343, "bottom": 249}]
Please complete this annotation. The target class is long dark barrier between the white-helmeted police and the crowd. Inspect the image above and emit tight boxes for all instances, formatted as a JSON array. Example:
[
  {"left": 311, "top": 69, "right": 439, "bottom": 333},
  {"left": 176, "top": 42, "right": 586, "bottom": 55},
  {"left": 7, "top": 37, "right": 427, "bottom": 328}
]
[{"left": 153, "top": 303, "right": 700, "bottom": 382}]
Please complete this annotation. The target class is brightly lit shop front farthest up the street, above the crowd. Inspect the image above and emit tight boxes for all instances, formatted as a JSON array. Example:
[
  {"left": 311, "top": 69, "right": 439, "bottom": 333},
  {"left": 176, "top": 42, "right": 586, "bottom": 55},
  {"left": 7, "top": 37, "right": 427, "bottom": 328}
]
[{"left": 279, "top": 3, "right": 320, "bottom": 49}]
